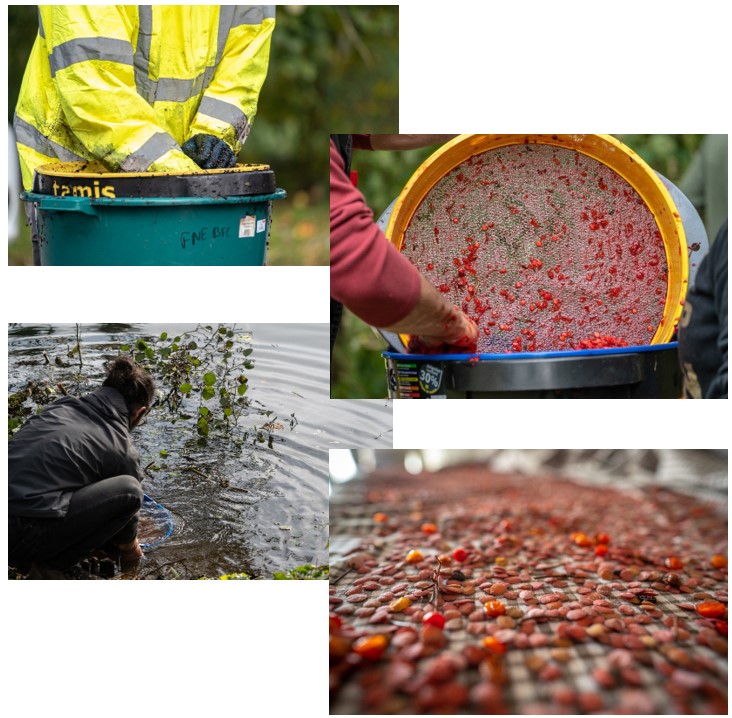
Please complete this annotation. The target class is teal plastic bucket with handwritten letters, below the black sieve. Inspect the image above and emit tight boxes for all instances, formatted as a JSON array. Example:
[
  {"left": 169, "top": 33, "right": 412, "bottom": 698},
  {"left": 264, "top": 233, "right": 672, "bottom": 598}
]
[{"left": 21, "top": 189, "right": 287, "bottom": 266}]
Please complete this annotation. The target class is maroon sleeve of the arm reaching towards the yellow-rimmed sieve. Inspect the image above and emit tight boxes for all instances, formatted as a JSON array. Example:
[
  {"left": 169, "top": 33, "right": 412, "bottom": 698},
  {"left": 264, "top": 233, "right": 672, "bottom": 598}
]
[{"left": 330, "top": 142, "right": 420, "bottom": 327}]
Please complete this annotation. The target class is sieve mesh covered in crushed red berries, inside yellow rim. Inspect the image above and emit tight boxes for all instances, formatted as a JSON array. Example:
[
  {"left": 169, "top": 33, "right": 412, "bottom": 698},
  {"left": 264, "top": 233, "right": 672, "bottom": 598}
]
[{"left": 402, "top": 144, "right": 668, "bottom": 353}]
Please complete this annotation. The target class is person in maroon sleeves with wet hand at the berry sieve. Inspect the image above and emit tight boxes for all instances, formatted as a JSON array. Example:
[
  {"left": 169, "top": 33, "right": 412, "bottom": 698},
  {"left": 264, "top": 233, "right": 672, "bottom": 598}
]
[{"left": 330, "top": 135, "right": 478, "bottom": 353}]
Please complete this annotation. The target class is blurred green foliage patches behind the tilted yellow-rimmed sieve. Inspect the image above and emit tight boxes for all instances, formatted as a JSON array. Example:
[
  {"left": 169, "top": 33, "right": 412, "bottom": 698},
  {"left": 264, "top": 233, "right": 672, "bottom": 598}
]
[{"left": 331, "top": 135, "right": 704, "bottom": 399}]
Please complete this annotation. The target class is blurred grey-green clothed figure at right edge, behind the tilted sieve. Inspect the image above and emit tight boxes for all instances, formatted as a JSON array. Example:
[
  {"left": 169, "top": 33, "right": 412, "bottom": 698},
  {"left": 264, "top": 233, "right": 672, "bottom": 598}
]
[{"left": 679, "top": 135, "right": 729, "bottom": 243}]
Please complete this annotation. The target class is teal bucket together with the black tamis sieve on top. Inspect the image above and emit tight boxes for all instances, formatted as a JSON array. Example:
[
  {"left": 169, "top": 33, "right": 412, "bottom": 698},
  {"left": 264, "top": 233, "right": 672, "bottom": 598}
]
[{"left": 21, "top": 165, "right": 286, "bottom": 266}]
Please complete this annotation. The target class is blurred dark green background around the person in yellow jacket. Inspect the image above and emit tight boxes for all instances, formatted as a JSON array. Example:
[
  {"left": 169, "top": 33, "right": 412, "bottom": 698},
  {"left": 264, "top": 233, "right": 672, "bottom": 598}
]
[{"left": 8, "top": 5, "right": 399, "bottom": 265}]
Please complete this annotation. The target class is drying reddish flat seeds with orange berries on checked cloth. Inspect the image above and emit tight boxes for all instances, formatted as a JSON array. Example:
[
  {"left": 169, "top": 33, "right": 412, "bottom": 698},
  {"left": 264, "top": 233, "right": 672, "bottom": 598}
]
[{"left": 329, "top": 467, "right": 727, "bottom": 715}]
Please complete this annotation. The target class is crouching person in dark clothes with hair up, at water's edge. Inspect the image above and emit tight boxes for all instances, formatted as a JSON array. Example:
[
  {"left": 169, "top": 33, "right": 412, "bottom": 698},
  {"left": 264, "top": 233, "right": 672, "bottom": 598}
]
[{"left": 8, "top": 356, "right": 155, "bottom": 579}]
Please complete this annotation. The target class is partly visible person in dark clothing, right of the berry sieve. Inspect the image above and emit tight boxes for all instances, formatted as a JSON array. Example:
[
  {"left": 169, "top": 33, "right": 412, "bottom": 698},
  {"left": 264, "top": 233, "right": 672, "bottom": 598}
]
[{"left": 678, "top": 219, "right": 729, "bottom": 399}]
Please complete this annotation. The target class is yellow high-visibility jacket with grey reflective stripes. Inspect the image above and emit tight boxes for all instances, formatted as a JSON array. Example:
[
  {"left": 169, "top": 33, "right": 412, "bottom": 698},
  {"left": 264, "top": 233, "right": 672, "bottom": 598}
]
[{"left": 14, "top": 5, "right": 275, "bottom": 189}]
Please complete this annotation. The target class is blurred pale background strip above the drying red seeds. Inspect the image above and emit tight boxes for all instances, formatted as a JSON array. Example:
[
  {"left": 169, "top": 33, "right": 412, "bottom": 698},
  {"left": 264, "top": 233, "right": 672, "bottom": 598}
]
[{"left": 330, "top": 449, "right": 728, "bottom": 503}]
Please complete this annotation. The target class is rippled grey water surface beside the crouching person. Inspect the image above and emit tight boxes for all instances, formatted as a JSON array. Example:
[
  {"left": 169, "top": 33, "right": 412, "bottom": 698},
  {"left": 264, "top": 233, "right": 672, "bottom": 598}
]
[{"left": 8, "top": 324, "right": 392, "bottom": 578}]
